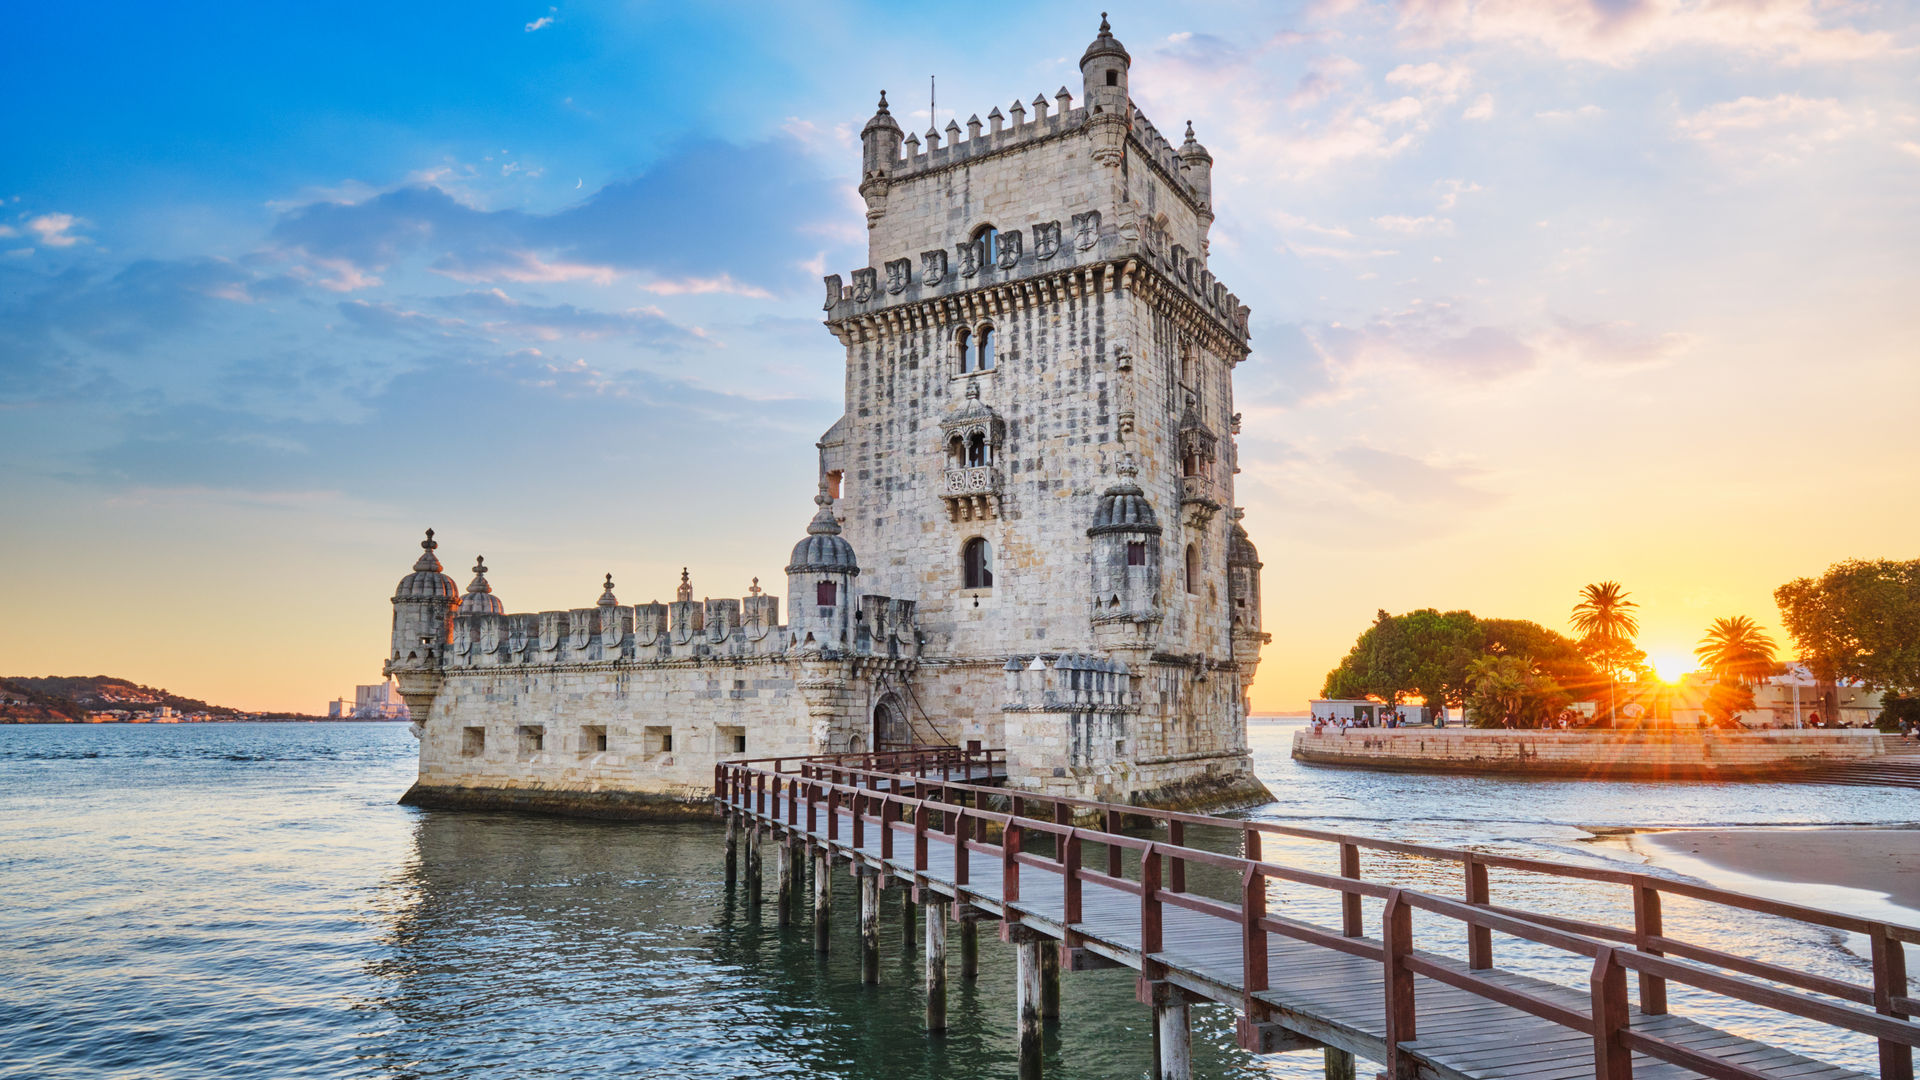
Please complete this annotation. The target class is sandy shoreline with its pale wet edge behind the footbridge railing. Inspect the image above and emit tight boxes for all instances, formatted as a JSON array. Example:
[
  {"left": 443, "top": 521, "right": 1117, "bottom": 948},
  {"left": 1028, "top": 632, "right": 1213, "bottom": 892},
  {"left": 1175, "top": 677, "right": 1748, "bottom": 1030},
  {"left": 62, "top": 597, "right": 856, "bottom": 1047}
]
[{"left": 1624, "top": 824, "right": 1920, "bottom": 924}]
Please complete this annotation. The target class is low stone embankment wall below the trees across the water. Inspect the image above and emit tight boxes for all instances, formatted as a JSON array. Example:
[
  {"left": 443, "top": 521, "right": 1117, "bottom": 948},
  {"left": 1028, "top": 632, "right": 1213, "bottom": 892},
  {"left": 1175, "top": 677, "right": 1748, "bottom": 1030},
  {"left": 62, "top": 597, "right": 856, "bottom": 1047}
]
[{"left": 1294, "top": 728, "right": 1897, "bottom": 780}]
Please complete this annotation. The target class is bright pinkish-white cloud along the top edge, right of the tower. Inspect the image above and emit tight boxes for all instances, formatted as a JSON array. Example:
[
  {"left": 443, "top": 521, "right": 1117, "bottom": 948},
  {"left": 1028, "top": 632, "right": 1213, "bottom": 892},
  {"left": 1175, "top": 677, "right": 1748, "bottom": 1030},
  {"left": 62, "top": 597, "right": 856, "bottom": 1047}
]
[{"left": 1396, "top": 0, "right": 1895, "bottom": 65}]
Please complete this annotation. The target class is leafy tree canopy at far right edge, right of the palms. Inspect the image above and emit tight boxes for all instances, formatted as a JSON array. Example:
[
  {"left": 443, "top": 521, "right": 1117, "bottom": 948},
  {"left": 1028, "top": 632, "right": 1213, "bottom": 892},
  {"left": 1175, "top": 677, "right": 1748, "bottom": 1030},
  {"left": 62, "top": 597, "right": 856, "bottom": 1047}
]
[{"left": 1774, "top": 559, "right": 1920, "bottom": 694}]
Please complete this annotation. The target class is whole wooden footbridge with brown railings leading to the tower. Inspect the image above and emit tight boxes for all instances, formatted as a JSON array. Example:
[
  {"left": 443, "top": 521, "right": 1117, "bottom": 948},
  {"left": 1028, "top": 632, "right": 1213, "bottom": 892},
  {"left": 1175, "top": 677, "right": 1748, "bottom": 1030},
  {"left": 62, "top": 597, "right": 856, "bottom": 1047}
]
[{"left": 714, "top": 749, "right": 1920, "bottom": 1080}]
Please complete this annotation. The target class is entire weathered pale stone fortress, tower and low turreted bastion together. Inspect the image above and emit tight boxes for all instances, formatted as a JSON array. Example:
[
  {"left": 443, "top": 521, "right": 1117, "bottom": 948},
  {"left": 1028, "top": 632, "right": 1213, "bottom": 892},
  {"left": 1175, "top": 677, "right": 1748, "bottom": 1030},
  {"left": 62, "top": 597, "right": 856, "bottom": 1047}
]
[{"left": 388, "top": 21, "right": 1267, "bottom": 815}]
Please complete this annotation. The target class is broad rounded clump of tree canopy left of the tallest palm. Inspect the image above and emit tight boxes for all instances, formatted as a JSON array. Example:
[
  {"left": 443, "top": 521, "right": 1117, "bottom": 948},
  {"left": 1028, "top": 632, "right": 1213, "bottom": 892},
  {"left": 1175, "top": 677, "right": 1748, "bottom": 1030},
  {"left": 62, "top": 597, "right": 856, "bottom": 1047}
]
[{"left": 1321, "top": 607, "right": 1605, "bottom": 707}]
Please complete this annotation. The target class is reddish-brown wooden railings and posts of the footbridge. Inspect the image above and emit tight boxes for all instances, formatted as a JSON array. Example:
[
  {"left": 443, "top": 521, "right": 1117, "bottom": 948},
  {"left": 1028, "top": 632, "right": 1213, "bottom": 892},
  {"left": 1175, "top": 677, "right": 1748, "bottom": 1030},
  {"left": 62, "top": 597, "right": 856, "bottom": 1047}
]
[{"left": 716, "top": 751, "right": 1920, "bottom": 1080}]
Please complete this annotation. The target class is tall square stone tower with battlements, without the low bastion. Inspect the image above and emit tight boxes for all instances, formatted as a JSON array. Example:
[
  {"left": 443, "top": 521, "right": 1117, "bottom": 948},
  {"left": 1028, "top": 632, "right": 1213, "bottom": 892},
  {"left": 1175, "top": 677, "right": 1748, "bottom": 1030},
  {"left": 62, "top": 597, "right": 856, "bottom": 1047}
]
[{"left": 820, "top": 17, "right": 1263, "bottom": 801}]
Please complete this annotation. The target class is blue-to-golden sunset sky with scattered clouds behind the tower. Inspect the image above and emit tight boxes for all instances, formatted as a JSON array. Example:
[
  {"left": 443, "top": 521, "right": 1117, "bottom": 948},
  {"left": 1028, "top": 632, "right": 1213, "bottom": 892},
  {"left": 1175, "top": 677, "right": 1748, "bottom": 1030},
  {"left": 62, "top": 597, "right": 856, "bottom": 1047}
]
[{"left": 0, "top": 0, "right": 1920, "bottom": 711}]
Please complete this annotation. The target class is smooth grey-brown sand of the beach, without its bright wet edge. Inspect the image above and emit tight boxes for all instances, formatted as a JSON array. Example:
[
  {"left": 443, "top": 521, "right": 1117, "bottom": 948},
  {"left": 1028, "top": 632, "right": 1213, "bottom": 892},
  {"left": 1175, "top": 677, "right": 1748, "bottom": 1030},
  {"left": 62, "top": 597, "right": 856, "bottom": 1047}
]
[{"left": 1632, "top": 828, "right": 1920, "bottom": 909}]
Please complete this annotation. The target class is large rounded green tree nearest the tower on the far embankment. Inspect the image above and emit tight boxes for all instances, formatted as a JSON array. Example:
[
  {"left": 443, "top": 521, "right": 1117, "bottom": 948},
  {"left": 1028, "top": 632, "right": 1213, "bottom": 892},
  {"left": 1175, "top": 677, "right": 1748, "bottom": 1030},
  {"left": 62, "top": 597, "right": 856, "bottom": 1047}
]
[{"left": 1321, "top": 607, "right": 1482, "bottom": 705}]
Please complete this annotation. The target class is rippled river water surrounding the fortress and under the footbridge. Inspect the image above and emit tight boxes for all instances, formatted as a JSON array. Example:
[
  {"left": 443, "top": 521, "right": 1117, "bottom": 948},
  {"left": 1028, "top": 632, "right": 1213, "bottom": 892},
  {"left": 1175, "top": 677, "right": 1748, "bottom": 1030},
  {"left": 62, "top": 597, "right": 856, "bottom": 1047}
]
[{"left": 0, "top": 723, "right": 1920, "bottom": 1080}]
